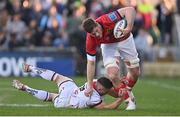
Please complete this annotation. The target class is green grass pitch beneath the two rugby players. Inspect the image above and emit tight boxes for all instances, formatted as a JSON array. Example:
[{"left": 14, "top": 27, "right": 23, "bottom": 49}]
[{"left": 0, "top": 77, "right": 180, "bottom": 116}]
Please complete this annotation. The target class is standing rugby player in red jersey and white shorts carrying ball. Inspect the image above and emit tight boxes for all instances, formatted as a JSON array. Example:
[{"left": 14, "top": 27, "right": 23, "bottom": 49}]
[{"left": 82, "top": 7, "right": 140, "bottom": 110}]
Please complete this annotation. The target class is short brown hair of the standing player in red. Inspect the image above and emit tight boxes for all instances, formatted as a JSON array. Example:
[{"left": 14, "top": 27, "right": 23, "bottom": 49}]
[{"left": 82, "top": 18, "right": 97, "bottom": 33}]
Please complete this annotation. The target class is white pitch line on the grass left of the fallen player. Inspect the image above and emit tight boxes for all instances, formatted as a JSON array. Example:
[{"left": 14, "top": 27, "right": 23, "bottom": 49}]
[{"left": 0, "top": 103, "right": 49, "bottom": 107}]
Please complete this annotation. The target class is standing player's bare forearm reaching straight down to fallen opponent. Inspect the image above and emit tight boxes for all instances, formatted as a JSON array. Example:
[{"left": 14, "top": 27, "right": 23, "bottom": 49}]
[{"left": 87, "top": 61, "right": 95, "bottom": 85}]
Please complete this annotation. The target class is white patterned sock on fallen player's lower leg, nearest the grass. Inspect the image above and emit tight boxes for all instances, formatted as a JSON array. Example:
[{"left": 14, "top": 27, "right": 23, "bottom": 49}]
[{"left": 25, "top": 86, "right": 49, "bottom": 101}]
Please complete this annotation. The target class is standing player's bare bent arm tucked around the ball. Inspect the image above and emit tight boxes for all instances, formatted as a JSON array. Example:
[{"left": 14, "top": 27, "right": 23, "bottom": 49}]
[{"left": 118, "top": 7, "right": 136, "bottom": 30}]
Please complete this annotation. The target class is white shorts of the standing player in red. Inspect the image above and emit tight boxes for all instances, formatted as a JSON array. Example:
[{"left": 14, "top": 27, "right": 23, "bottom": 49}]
[{"left": 101, "top": 34, "right": 139, "bottom": 68}]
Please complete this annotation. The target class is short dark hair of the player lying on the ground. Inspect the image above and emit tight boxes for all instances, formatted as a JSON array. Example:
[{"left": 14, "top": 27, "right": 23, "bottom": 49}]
[{"left": 97, "top": 77, "right": 113, "bottom": 89}]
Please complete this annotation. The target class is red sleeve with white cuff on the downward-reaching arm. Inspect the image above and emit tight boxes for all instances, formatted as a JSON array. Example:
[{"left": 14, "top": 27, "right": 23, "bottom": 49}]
[{"left": 86, "top": 33, "right": 97, "bottom": 61}]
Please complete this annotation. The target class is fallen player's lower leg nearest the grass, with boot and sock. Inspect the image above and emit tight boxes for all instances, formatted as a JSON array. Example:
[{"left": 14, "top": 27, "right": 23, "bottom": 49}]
[{"left": 12, "top": 80, "right": 59, "bottom": 101}]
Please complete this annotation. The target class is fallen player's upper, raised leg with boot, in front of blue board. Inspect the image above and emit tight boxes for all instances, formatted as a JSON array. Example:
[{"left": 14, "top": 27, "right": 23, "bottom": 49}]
[{"left": 22, "top": 64, "right": 73, "bottom": 86}]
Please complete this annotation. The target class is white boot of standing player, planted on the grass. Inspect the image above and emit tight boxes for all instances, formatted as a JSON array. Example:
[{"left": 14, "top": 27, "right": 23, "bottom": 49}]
[{"left": 125, "top": 91, "right": 136, "bottom": 111}]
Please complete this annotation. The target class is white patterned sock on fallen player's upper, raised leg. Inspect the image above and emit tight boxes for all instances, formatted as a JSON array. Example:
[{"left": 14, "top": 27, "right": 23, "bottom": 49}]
[{"left": 29, "top": 66, "right": 56, "bottom": 81}]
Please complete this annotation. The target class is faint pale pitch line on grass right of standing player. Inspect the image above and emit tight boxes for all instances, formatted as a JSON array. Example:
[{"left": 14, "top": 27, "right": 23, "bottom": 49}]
[{"left": 145, "top": 81, "right": 180, "bottom": 91}]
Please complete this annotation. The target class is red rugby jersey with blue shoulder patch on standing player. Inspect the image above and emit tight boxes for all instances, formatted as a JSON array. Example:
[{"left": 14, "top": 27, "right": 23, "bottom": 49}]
[{"left": 86, "top": 11, "right": 129, "bottom": 56}]
